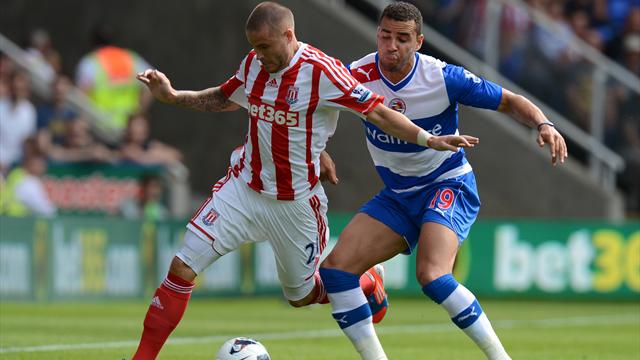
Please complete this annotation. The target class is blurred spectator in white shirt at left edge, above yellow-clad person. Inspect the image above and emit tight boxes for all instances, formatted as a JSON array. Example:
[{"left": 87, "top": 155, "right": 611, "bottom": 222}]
[{"left": 0, "top": 72, "right": 36, "bottom": 173}]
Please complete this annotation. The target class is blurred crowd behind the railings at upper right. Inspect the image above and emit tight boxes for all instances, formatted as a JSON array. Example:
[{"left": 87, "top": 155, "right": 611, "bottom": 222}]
[{"left": 416, "top": 0, "right": 640, "bottom": 139}]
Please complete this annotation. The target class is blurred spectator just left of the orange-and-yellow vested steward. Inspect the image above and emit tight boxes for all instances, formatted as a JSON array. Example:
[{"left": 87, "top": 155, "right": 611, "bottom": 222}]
[{"left": 27, "top": 29, "right": 62, "bottom": 82}]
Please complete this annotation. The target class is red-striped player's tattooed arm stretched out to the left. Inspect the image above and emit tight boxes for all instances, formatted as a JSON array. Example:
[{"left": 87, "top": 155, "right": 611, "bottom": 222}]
[{"left": 136, "top": 69, "right": 240, "bottom": 112}]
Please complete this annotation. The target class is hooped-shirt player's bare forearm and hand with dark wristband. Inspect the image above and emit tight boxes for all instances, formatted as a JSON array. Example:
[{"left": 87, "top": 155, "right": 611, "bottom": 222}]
[{"left": 498, "top": 88, "right": 568, "bottom": 166}]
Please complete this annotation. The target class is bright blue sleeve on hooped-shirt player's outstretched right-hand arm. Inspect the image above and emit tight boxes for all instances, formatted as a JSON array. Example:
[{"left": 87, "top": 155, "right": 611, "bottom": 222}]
[{"left": 442, "top": 64, "right": 502, "bottom": 110}]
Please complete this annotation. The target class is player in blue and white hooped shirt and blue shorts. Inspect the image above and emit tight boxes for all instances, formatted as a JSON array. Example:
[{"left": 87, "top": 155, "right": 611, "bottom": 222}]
[{"left": 320, "top": 2, "right": 567, "bottom": 360}]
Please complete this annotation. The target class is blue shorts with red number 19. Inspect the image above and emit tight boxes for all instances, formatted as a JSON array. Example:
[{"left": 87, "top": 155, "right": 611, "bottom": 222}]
[{"left": 360, "top": 172, "right": 480, "bottom": 254}]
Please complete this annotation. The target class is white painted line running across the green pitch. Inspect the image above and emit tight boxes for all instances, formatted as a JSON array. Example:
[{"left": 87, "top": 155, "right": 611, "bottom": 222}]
[{"left": 0, "top": 313, "right": 640, "bottom": 354}]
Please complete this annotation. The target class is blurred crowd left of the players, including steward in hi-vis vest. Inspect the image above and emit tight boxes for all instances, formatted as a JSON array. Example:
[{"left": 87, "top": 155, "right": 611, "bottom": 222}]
[{"left": 0, "top": 28, "right": 182, "bottom": 220}]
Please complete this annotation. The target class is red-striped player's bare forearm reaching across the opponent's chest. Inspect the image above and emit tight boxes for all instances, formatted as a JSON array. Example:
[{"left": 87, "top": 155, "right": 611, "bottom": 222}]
[{"left": 367, "top": 104, "right": 480, "bottom": 151}]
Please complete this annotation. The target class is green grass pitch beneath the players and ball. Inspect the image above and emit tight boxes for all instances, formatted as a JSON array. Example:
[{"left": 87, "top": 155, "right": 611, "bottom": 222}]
[{"left": 0, "top": 298, "right": 640, "bottom": 360}]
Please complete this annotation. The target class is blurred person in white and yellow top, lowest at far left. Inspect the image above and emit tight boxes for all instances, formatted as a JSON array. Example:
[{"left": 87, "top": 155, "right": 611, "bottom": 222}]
[{"left": 0, "top": 138, "right": 57, "bottom": 216}]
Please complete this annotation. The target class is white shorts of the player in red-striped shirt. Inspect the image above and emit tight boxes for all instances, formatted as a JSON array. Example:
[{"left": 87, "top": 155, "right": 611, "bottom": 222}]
[{"left": 176, "top": 171, "right": 329, "bottom": 301}]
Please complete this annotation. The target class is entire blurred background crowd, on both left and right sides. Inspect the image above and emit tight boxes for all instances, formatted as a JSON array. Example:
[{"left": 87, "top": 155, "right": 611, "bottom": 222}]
[{"left": 0, "top": 0, "right": 640, "bottom": 219}]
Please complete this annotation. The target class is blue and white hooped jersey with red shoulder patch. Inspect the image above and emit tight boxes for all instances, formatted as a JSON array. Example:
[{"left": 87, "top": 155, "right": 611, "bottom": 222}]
[{"left": 349, "top": 53, "right": 502, "bottom": 192}]
